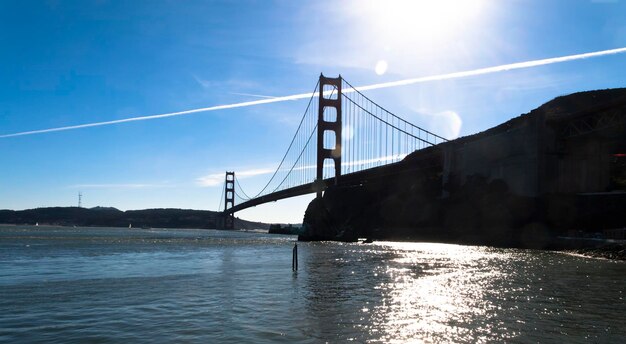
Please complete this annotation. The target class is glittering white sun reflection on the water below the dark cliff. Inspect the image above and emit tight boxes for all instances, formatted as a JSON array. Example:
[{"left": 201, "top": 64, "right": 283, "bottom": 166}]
[{"left": 373, "top": 242, "right": 515, "bottom": 342}]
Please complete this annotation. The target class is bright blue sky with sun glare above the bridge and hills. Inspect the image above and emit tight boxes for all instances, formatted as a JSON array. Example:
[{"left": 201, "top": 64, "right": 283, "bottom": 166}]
[{"left": 0, "top": 0, "right": 626, "bottom": 222}]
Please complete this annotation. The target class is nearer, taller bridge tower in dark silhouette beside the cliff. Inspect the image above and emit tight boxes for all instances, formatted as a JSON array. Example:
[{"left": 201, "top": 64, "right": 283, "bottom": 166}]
[{"left": 315, "top": 74, "right": 342, "bottom": 198}]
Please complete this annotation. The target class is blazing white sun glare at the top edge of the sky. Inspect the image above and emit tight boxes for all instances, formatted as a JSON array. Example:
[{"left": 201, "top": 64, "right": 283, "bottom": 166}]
[{"left": 350, "top": 0, "right": 487, "bottom": 75}]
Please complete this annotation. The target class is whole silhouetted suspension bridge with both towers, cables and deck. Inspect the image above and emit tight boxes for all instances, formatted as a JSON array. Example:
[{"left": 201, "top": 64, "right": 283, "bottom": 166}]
[{"left": 219, "top": 75, "right": 447, "bottom": 229}]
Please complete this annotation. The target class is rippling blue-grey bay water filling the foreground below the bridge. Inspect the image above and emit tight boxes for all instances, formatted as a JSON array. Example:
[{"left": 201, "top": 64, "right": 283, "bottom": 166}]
[{"left": 0, "top": 226, "right": 626, "bottom": 343}]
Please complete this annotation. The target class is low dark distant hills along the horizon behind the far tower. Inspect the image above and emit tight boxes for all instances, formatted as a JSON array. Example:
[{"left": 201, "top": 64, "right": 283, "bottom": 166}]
[{"left": 0, "top": 207, "right": 269, "bottom": 229}]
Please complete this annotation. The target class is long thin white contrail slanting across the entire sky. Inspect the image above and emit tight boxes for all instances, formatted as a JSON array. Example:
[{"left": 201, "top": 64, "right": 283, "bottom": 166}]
[{"left": 0, "top": 47, "right": 626, "bottom": 138}]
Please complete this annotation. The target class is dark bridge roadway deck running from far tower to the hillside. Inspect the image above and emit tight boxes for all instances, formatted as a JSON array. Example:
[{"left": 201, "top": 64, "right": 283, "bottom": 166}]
[{"left": 224, "top": 147, "right": 442, "bottom": 214}]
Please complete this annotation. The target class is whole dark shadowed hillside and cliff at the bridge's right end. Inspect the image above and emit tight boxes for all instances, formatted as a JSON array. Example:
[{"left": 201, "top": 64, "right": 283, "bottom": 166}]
[{"left": 300, "top": 89, "right": 626, "bottom": 248}]
